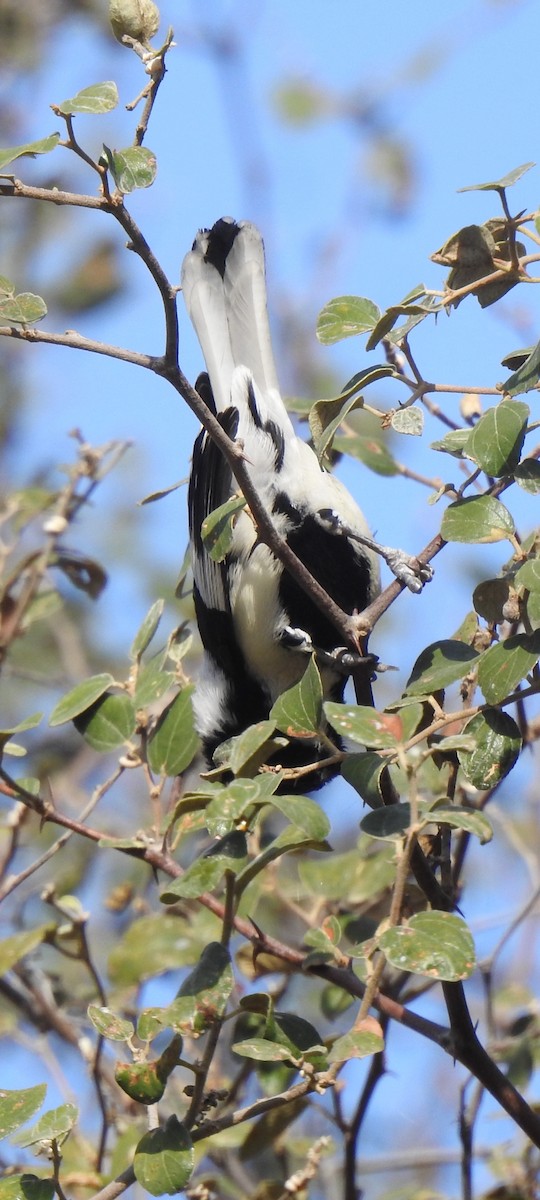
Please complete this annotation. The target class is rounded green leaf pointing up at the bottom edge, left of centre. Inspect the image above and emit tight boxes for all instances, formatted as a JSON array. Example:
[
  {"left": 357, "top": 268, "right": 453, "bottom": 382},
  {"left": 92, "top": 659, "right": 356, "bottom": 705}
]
[{"left": 133, "top": 1116, "right": 194, "bottom": 1196}]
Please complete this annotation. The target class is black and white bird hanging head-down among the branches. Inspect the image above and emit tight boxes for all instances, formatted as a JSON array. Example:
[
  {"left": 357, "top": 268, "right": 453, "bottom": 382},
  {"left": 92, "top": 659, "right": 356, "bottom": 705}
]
[{"left": 181, "top": 217, "right": 379, "bottom": 790}]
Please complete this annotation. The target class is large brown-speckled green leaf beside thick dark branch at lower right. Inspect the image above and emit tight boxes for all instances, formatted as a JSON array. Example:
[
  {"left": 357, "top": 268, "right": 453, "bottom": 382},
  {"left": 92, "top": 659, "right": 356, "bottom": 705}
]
[{"left": 378, "top": 912, "right": 475, "bottom": 983}]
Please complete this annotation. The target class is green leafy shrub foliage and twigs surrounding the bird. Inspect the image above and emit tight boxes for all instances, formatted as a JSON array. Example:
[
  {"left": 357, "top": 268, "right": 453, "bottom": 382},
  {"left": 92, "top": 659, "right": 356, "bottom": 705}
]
[{"left": 0, "top": 0, "right": 540, "bottom": 1200}]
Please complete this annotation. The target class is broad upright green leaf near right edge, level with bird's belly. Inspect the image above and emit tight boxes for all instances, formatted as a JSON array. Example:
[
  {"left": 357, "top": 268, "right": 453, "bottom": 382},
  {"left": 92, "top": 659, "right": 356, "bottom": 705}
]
[{"left": 464, "top": 400, "right": 530, "bottom": 479}]
